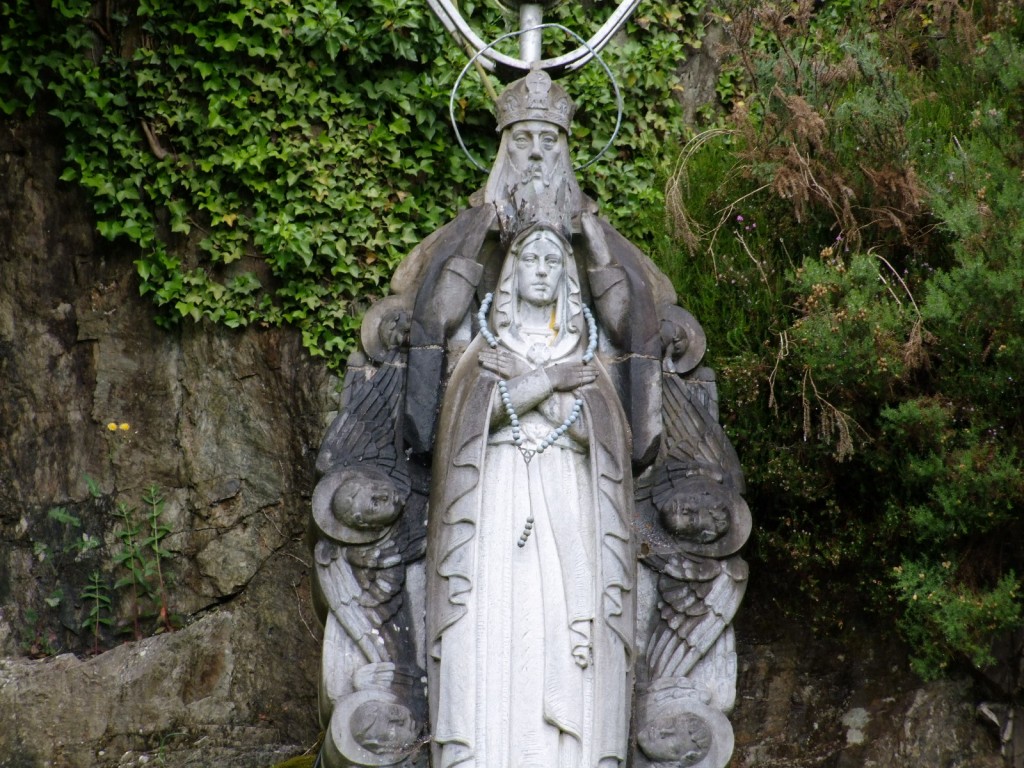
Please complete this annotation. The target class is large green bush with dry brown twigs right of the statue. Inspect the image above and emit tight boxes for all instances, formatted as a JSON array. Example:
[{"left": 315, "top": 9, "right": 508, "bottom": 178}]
[{"left": 669, "top": 0, "right": 1024, "bottom": 677}]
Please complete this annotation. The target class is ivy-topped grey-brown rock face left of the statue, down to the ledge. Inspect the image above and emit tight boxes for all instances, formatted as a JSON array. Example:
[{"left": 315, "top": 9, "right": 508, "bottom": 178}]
[{"left": 0, "top": 121, "right": 331, "bottom": 767}]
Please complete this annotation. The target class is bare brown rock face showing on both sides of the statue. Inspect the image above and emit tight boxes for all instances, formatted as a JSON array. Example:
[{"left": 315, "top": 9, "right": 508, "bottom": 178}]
[{"left": 0, "top": 115, "right": 1001, "bottom": 768}]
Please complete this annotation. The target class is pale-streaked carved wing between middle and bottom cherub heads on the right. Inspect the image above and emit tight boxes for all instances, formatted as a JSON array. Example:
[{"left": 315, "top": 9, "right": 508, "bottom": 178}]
[{"left": 647, "top": 555, "right": 748, "bottom": 679}]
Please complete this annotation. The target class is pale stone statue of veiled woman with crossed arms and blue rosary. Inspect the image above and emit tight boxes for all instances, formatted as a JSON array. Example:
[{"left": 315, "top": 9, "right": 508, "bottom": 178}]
[{"left": 427, "top": 222, "right": 636, "bottom": 768}]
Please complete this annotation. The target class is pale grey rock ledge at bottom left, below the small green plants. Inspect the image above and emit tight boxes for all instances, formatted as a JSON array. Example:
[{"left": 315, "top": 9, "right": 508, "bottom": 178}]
[{"left": 0, "top": 553, "right": 315, "bottom": 768}]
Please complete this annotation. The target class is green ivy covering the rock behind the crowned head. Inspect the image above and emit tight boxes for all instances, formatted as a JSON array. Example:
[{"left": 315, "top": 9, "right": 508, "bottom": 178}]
[{"left": 0, "top": 0, "right": 700, "bottom": 366}]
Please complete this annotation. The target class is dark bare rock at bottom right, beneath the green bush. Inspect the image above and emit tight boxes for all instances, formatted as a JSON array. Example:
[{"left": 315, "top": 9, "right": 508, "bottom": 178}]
[{"left": 731, "top": 578, "right": 1004, "bottom": 768}]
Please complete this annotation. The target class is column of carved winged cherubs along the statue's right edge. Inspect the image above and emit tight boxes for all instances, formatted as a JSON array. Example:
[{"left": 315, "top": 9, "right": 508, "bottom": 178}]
[{"left": 636, "top": 305, "right": 752, "bottom": 768}]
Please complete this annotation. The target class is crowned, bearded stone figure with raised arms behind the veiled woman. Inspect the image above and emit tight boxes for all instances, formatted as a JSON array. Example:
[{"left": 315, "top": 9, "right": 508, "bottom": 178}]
[{"left": 391, "top": 71, "right": 676, "bottom": 464}]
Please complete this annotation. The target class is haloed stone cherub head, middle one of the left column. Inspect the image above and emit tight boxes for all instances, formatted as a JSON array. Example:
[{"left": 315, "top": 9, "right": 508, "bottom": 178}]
[{"left": 313, "top": 465, "right": 409, "bottom": 544}]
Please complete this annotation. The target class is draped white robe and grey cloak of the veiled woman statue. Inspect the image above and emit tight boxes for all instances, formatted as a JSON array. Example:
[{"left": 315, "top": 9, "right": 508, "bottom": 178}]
[{"left": 427, "top": 315, "right": 636, "bottom": 768}]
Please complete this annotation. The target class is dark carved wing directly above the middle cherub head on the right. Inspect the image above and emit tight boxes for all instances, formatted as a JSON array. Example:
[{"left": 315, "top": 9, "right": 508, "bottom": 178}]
[{"left": 662, "top": 376, "right": 743, "bottom": 494}]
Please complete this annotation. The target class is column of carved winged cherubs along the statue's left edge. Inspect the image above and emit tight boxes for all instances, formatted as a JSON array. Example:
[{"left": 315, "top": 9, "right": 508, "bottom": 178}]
[{"left": 311, "top": 300, "right": 426, "bottom": 768}]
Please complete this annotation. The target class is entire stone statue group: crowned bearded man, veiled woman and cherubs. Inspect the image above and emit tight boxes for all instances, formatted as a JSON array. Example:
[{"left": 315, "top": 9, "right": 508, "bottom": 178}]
[{"left": 311, "top": 7, "right": 751, "bottom": 768}]
